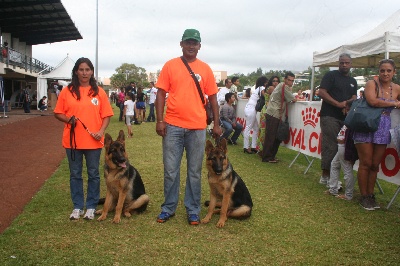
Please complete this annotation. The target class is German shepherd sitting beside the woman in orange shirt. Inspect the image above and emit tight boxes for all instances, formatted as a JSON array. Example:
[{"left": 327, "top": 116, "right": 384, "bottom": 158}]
[{"left": 96, "top": 130, "right": 149, "bottom": 223}]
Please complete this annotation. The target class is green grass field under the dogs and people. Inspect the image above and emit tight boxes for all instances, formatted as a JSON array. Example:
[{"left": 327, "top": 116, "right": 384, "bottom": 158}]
[{"left": 0, "top": 109, "right": 400, "bottom": 265}]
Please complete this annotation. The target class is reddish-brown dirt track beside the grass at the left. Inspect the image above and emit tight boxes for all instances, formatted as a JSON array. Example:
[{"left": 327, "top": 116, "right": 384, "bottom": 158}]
[{"left": 0, "top": 115, "right": 65, "bottom": 233}]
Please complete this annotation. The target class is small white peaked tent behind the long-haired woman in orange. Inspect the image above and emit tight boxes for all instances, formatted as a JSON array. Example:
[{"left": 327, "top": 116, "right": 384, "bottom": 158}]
[{"left": 37, "top": 55, "right": 75, "bottom": 109}]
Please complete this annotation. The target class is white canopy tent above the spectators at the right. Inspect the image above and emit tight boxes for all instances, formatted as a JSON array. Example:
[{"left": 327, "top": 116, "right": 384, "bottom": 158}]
[{"left": 311, "top": 10, "right": 400, "bottom": 92}]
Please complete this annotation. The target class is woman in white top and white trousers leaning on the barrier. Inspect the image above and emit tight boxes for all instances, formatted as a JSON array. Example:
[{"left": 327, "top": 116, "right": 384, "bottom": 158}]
[{"left": 243, "top": 76, "right": 268, "bottom": 154}]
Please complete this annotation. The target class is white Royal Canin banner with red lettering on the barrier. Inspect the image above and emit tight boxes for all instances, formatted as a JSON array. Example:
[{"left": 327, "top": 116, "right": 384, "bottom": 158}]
[{"left": 236, "top": 99, "right": 400, "bottom": 186}]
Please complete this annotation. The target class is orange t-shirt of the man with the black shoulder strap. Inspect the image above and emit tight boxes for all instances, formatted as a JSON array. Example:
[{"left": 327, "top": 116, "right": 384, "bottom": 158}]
[{"left": 156, "top": 57, "right": 218, "bottom": 129}]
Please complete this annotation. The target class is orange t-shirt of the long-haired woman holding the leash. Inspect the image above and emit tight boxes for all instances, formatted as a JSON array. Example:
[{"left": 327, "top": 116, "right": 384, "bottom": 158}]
[{"left": 54, "top": 87, "right": 114, "bottom": 149}]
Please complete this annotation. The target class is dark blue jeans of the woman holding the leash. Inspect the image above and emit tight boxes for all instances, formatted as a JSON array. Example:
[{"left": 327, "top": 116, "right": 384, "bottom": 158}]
[{"left": 65, "top": 148, "right": 101, "bottom": 210}]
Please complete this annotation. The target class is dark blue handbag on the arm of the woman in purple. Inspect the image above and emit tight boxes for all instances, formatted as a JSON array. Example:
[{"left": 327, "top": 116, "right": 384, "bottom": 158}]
[{"left": 344, "top": 81, "right": 384, "bottom": 133}]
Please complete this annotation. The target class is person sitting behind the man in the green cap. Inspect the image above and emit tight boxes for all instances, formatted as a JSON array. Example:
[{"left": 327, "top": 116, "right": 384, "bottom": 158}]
[{"left": 219, "top": 92, "right": 243, "bottom": 145}]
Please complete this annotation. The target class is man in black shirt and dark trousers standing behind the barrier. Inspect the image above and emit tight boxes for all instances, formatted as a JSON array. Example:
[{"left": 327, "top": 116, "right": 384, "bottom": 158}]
[{"left": 319, "top": 54, "right": 357, "bottom": 184}]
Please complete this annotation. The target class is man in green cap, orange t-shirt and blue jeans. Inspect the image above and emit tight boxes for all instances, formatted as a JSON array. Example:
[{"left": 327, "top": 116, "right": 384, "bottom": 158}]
[{"left": 156, "top": 29, "right": 222, "bottom": 225}]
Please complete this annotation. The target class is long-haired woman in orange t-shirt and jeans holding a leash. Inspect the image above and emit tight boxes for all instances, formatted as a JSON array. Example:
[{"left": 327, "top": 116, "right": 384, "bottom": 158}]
[{"left": 54, "top": 57, "right": 113, "bottom": 220}]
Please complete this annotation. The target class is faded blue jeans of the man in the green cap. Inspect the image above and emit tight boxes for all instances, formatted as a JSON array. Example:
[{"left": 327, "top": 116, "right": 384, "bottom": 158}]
[{"left": 161, "top": 124, "right": 206, "bottom": 214}]
